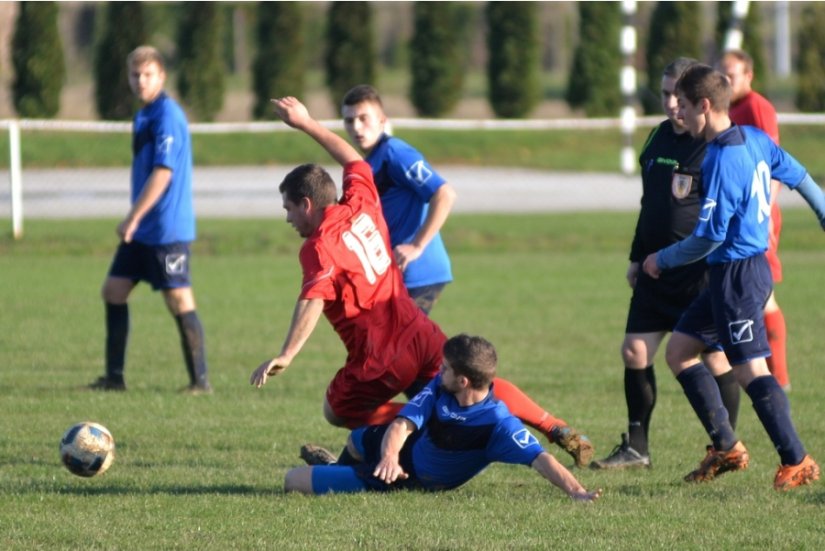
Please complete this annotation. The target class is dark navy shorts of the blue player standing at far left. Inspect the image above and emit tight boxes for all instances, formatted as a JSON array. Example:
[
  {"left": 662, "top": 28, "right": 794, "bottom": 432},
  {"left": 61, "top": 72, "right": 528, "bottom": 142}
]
[{"left": 109, "top": 241, "right": 192, "bottom": 291}]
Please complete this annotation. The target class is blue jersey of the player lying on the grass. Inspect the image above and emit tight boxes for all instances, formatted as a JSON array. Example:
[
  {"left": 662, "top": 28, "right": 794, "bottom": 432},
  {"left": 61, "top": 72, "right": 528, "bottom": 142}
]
[{"left": 398, "top": 375, "right": 544, "bottom": 490}]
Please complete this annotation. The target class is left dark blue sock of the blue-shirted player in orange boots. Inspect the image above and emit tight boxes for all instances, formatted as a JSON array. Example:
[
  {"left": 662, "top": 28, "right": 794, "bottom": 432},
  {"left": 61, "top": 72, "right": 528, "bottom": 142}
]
[{"left": 676, "top": 363, "right": 737, "bottom": 450}]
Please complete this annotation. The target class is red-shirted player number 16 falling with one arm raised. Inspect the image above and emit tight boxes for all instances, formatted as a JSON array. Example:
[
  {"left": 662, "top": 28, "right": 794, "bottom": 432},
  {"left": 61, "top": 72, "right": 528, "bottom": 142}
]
[{"left": 250, "top": 97, "right": 593, "bottom": 466}]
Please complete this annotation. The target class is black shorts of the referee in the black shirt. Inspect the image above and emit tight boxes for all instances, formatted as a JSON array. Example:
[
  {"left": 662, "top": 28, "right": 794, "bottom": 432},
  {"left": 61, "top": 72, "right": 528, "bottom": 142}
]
[{"left": 625, "top": 272, "right": 704, "bottom": 333}]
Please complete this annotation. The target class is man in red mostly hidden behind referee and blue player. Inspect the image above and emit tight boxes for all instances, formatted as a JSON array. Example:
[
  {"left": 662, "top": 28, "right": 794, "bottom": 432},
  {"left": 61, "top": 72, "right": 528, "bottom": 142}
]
[{"left": 719, "top": 50, "right": 791, "bottom": 392}]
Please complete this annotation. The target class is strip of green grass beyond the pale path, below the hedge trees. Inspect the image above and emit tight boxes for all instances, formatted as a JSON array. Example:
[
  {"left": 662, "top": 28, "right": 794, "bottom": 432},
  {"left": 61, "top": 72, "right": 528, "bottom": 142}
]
[{"left": 0, "top": 125, "right": 825, "bottom": 180}]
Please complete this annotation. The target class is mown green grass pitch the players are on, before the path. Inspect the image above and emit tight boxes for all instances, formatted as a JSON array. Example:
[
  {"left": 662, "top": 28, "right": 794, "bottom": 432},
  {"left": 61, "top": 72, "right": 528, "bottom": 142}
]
[{"left": 0, "top": 210, "right": 825, "bottom": 550}]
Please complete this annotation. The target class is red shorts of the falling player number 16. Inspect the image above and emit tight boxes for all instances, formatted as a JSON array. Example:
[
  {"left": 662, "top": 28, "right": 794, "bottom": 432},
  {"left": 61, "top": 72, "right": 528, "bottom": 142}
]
[{"left": 326, "top": 324, "right": 447, "bottom": 421}]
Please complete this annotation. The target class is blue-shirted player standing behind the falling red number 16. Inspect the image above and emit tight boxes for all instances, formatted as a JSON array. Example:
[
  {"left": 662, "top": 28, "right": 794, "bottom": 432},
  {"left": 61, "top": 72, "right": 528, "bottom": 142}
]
[{"left": 341, "top": 85, "right": 456, "bottom": 314}]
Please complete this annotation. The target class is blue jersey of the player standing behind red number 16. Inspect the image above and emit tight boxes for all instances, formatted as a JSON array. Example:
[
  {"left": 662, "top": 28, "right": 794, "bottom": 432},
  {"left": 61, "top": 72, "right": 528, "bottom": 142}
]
[{"left": 366, "top": 135, "right": 453, "bottom": 288}]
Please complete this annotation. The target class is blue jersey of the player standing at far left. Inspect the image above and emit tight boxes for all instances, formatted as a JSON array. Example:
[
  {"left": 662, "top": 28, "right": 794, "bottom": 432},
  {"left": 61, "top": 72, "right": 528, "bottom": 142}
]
[{"left": 132, "top": 93, "right": 195, "bottom": 245}]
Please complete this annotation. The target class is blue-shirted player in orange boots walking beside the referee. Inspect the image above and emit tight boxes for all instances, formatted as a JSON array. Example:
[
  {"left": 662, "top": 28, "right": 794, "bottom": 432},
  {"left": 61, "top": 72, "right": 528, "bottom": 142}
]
[{"left": 644, "top": 65, "right": 825, "bottom": 490}]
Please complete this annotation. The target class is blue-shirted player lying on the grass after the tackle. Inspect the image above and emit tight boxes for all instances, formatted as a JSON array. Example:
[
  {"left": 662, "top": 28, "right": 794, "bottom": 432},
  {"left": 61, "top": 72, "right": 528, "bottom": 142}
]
[{"left": 284, "top": 335, "right": 602, "bottom": 501}]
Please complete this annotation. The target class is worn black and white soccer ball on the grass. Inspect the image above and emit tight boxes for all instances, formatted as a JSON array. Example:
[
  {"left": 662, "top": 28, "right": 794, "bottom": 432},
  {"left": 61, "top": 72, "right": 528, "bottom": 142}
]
[{"left": 60, "top": 421, "right": 115, "bottom": 477}]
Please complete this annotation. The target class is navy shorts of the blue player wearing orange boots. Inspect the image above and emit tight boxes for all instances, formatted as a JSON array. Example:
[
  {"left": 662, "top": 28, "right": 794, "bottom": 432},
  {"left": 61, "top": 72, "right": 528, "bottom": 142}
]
[{"left": 674, "top": 254, "right": 773, "bottom": 365}]
